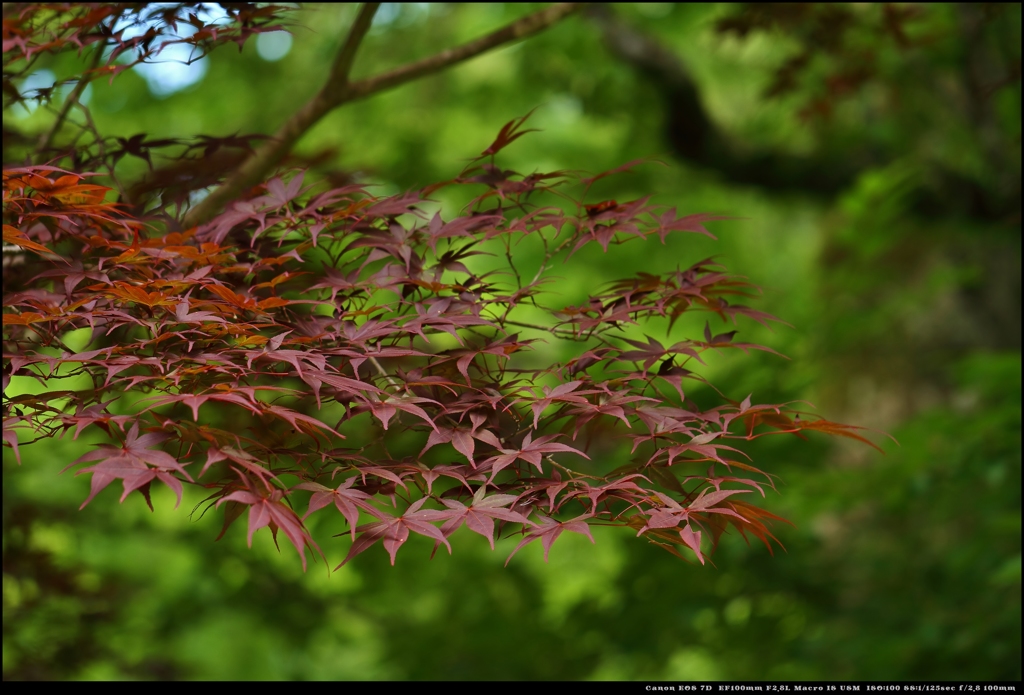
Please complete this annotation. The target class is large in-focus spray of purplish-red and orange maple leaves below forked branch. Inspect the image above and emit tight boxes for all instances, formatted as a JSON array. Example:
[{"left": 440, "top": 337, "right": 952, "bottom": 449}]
[{"left": 3, "top": 146, "right": 872, "bottom": 562}]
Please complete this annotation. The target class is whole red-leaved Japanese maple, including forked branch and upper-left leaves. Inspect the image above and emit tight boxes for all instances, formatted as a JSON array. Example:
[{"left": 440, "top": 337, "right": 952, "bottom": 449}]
[{"left": 3, "top": 3, "right": 869, "bottom": 566}]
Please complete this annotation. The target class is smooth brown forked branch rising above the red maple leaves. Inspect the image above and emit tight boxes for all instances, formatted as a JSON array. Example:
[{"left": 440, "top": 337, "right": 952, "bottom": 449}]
[{"left": 183, "top": 3, "right": 581, "bottom": 227}]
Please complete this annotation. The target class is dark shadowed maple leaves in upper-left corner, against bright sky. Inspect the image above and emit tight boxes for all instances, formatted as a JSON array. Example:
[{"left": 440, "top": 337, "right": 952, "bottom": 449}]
[{"left": 3, "top": 3, "right": 292, "bottom": 210}]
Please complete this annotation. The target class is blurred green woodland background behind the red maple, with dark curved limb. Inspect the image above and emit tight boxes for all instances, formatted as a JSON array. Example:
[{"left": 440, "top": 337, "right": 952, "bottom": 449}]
[{"left": 3, "top": 3, "right": 1021, "bottom": 680}]
